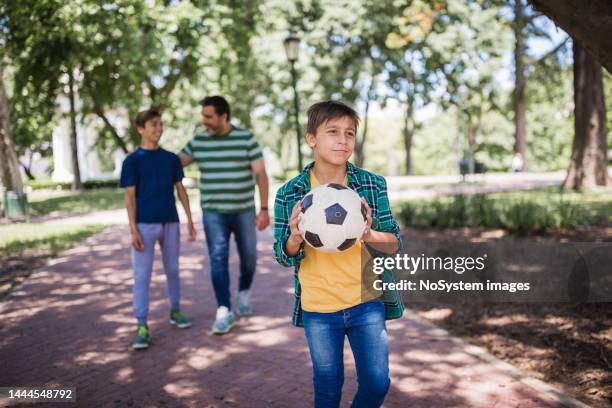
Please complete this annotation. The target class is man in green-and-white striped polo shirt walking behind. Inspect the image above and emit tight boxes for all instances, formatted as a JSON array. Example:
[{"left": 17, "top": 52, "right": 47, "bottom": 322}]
[{"left": 179, "top": 96, "right": 270, "bottom": 334}]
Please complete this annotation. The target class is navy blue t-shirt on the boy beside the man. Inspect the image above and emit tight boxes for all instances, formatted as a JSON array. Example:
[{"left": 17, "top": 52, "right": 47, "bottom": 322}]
[{"left": 120, "top": 147, "right": 184, "bottom": 224}]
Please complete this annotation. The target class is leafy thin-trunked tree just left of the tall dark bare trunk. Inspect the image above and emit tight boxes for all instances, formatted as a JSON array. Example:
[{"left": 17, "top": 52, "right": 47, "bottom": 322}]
[{"left": 416, "top": 0, "right": 510, "bottom": 172}]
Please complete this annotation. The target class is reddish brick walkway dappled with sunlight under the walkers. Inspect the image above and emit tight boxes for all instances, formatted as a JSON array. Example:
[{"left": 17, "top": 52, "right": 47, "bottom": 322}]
[{"left": 0, "top": 225, "right": 577, "bottom": 408}]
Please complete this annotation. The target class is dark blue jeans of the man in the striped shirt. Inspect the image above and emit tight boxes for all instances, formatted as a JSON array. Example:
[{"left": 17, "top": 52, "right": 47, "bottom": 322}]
[{"left": 203, "top": 210, "right": 257, "bottom": 309}]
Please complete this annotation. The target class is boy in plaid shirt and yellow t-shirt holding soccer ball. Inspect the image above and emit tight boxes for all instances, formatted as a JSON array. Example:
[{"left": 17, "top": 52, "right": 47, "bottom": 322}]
[{"left": 274, "top": 101, "right": 404, "bottom": 408}]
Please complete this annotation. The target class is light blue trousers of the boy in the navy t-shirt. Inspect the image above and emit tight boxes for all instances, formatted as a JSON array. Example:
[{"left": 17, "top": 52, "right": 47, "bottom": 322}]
[{"left": 132, "top": 222, "right": 181, "bottom": 324}]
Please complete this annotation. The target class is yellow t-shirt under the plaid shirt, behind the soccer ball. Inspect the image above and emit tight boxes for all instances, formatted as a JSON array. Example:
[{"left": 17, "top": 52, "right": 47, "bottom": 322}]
[{"left": 298, "top": 170, "right": 363, "bottom": 313}]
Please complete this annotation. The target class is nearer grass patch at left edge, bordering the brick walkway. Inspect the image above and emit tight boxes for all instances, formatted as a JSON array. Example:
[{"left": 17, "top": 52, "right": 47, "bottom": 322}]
[{"left": 0, "top": 222, "right": 105, "bottom": 256}]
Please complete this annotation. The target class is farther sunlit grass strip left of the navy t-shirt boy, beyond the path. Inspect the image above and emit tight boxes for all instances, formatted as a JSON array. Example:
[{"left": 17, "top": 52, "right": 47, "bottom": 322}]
[{"left": 28, "top": 188, "right": 124, "bottom": 216}]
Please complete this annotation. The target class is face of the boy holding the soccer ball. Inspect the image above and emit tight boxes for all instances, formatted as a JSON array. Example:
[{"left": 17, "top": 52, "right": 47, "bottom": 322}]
[{"left": 306, "top": 116, "right": 357, "bottom": 165}]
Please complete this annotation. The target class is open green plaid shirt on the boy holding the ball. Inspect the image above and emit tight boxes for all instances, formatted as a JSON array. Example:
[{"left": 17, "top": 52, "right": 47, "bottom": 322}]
[{"left": 274, "top": 162, "right": 404, "bottom": 327}]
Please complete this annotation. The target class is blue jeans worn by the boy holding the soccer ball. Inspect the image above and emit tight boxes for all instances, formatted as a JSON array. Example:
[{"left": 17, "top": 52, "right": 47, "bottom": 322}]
[{"left": 303, "top": 300, "right": 391, "bottom": 408}]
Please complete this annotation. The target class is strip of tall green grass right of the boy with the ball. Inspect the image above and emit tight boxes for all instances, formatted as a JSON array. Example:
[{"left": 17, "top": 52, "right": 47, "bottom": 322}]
[{"left": 398, "top": 187, "right": 612, "bottom": 235}]
